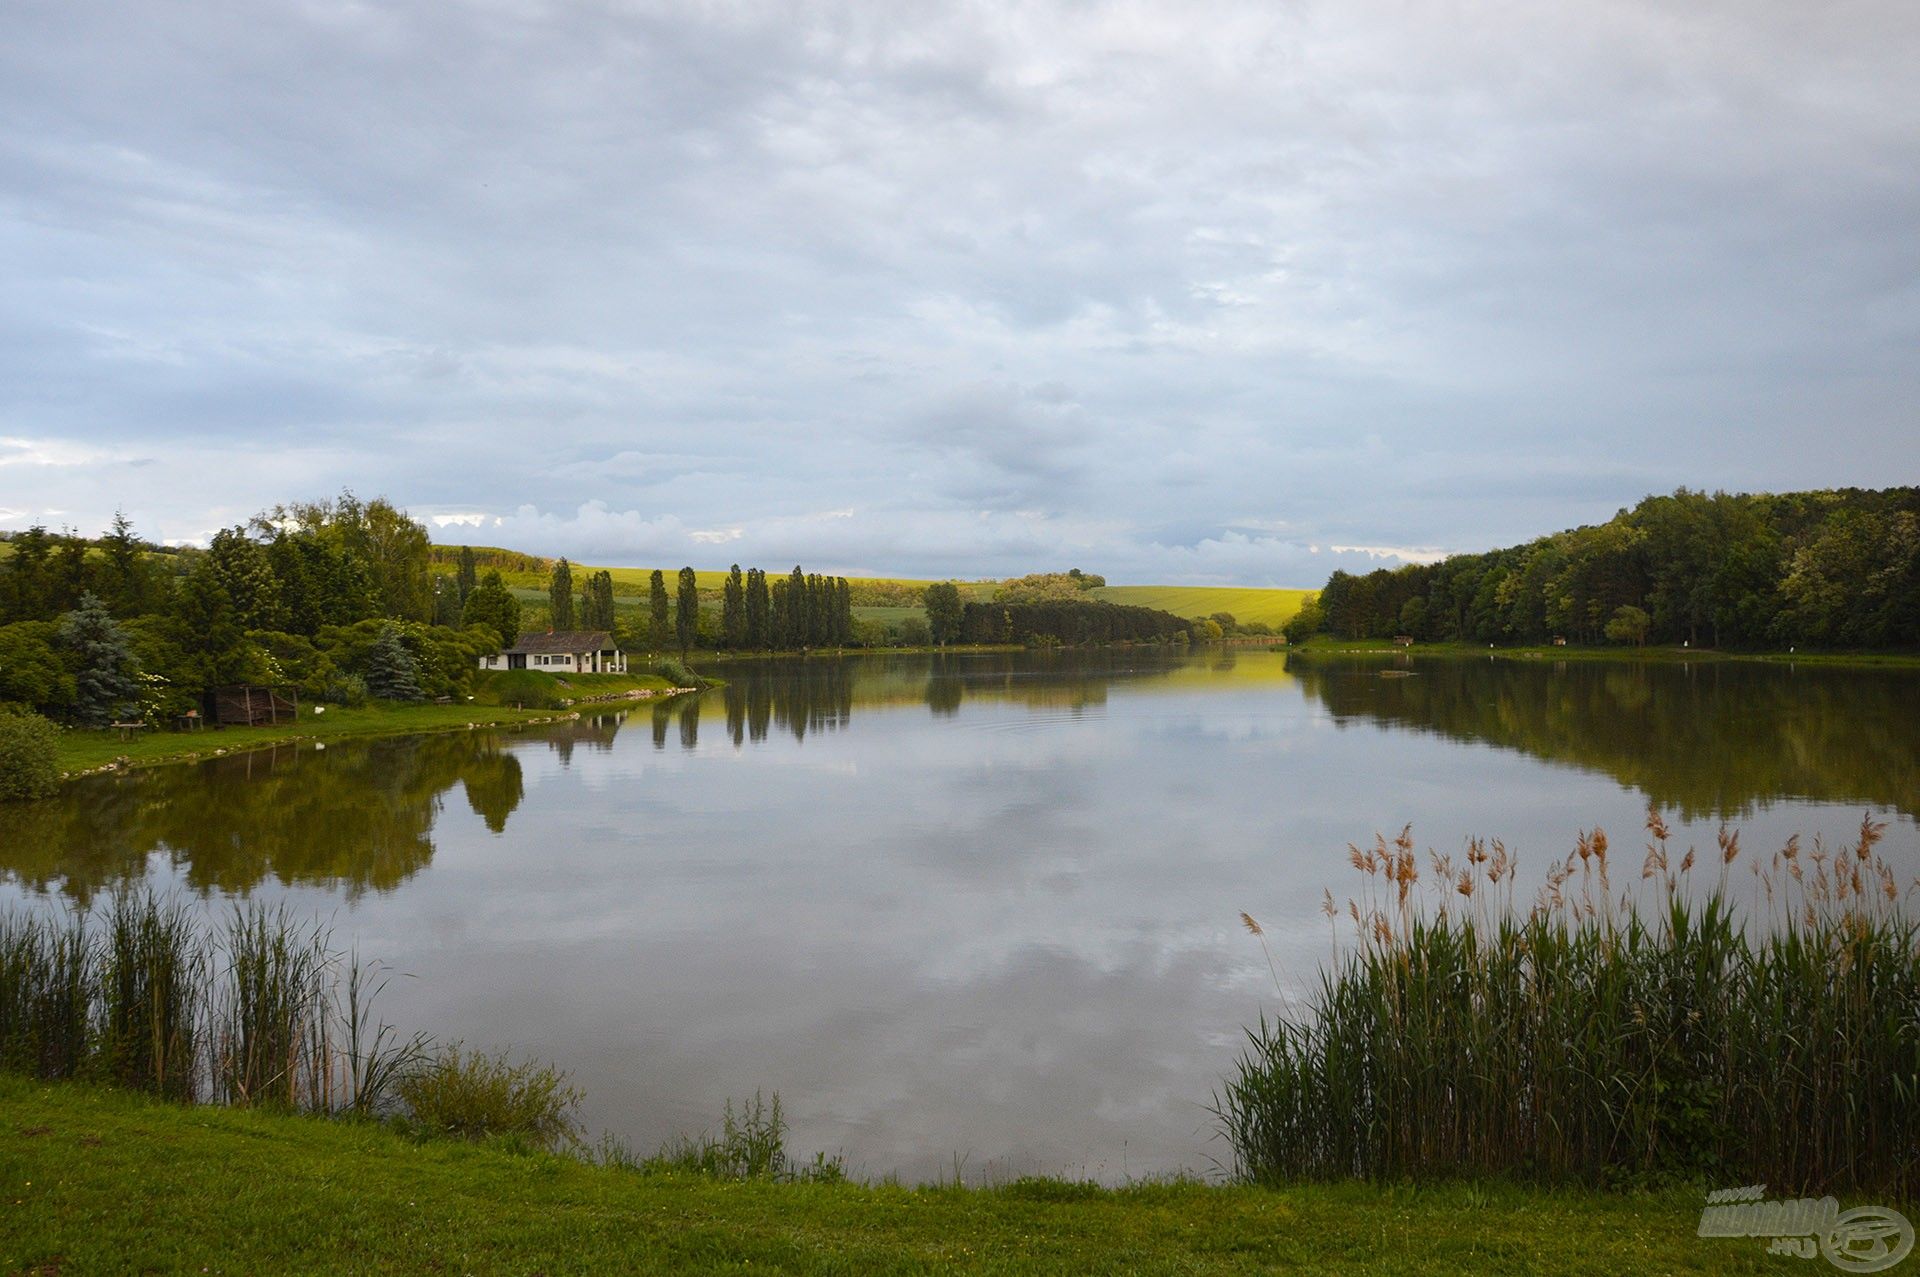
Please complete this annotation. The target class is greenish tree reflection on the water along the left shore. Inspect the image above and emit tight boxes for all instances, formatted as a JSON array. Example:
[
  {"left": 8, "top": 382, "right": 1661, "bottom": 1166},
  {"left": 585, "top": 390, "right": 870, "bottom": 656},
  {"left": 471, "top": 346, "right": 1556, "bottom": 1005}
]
[{"left": 0, "top": 724, "right": 526, "bottom": 901}]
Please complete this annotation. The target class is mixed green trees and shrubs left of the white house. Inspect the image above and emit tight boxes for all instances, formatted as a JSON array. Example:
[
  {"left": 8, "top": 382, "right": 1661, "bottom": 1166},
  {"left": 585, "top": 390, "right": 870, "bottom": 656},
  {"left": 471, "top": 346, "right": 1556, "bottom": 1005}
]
[{"left": 0, "top": 492, "right": 518, "bottom": 748}]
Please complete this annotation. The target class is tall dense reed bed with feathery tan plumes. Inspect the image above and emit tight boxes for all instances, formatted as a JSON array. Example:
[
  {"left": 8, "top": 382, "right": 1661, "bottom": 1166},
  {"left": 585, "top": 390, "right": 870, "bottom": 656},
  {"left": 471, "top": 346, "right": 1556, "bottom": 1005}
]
[{"left": 1215, "top": 810, "right": 1920, "bottom": 1200}]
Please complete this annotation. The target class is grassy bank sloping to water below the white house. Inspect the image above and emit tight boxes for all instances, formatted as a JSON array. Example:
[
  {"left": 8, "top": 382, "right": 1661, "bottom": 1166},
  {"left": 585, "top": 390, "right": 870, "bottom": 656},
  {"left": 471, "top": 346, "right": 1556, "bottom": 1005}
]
[{"left": 46, "top": 670, "right": 672, "bottom": 776}]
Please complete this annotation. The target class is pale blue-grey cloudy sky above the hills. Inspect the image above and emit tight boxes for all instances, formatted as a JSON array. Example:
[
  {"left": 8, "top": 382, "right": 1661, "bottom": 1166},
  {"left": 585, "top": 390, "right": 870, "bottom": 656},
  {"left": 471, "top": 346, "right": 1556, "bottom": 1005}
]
[{"left": 0, "top": 0, "right": 1920, "bottom": 586}]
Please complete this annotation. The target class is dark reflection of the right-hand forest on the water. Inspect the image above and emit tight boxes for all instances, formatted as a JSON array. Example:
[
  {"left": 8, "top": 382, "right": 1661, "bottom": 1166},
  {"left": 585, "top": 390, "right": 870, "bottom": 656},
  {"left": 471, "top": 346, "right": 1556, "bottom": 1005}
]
[{"left": 1288, "top": 659, "right": 1920, "bottom": 820}]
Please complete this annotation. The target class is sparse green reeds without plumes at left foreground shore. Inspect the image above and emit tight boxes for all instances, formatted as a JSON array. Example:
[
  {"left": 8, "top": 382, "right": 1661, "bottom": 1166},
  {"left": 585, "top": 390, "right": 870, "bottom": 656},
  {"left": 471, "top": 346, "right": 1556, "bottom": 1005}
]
[{"left": 0, "top": 891, "right": 426, "bottom": 1116}]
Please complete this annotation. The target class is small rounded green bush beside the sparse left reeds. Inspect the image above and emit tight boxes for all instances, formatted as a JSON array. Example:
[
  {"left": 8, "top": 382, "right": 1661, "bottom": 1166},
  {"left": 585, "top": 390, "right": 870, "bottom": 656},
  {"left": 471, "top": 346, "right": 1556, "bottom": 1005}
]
[{"left": 399, "top": 1043, "right": 580, "bottom": 1150}]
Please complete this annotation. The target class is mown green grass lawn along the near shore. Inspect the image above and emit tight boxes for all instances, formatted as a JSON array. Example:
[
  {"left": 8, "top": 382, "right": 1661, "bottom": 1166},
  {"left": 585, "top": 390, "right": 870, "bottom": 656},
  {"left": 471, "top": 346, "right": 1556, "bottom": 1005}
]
[{"left": 0, "top": 1077, "right": 1781, "bottom": 1277}]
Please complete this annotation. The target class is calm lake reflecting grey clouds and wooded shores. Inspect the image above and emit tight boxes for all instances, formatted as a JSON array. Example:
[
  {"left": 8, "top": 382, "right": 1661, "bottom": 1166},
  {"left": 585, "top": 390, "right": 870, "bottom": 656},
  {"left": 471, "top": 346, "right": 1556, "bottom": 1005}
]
[{"left": 0, "top": 649, "right": 1920, "bottom": 1181}]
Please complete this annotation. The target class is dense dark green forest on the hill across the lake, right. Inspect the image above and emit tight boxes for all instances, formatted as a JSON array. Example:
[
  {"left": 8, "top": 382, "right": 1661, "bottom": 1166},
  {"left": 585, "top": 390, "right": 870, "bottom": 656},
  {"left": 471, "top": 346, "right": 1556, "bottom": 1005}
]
[{"left": 1288, "top": 488, "right": 1920, "bottom": 649}]
